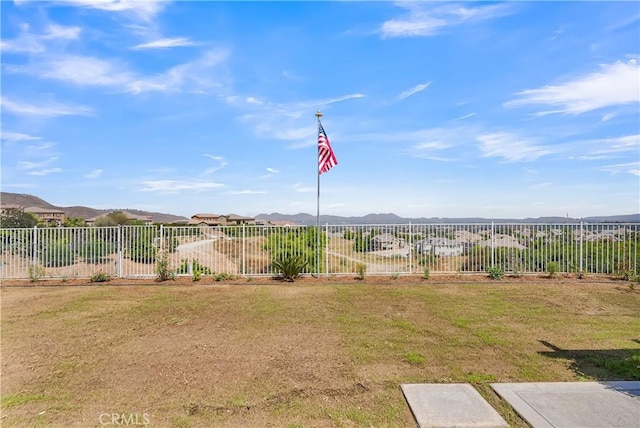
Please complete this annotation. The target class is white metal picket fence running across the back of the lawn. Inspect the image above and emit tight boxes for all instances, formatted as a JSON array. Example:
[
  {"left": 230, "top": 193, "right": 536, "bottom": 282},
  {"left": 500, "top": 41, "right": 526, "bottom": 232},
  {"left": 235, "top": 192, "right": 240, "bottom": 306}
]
[{"left": 0, "top": 223, "right": 640, "bottom": 279}]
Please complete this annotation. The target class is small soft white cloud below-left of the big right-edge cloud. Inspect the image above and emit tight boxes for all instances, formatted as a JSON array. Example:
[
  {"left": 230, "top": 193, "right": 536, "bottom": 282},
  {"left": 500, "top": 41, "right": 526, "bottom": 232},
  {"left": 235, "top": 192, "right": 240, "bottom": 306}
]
[{"left": 476, "top": 132, "right": 554, "bottom": 162}]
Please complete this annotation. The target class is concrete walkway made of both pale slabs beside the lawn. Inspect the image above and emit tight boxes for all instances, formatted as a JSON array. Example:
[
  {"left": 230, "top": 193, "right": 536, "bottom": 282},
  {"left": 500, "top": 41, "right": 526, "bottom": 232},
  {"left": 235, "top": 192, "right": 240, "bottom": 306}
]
[{"left": 401, "top": 382, "right": 640, "bottom": 428}]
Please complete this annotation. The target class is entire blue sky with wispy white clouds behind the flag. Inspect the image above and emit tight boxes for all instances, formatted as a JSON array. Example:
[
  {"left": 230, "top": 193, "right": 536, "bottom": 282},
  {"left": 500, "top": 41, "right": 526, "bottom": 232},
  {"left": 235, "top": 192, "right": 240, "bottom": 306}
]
[{"left": 0, "top": 0, "right": 640, "bottom": 218}]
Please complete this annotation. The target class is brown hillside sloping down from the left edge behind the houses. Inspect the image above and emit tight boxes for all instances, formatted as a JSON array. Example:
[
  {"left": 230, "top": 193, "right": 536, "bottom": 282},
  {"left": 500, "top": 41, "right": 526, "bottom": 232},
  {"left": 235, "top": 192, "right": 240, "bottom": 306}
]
[{"left": 0, "top": 192, "right": 188, "bottom": 223}]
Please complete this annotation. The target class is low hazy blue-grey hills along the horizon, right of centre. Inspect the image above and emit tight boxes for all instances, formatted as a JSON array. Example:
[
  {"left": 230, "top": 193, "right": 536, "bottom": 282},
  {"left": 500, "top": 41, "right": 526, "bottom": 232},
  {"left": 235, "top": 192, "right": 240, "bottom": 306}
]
[{"left": 256, "top": 213, "right": 640, "bottom": 226}]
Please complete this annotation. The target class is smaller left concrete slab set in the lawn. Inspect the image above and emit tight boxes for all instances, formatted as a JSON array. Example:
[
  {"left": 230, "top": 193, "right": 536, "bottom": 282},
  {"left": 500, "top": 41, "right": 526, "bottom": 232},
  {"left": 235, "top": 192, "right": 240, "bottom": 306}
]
[{"left": 400, "top": 383, "right": 509, "bottom": 428}]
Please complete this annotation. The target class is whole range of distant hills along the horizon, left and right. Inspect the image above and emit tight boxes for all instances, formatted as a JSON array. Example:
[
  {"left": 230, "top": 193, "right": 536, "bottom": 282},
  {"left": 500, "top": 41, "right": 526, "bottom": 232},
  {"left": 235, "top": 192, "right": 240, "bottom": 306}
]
[{"left": 0, "top": 192, "right": 640, "bottom": 226}]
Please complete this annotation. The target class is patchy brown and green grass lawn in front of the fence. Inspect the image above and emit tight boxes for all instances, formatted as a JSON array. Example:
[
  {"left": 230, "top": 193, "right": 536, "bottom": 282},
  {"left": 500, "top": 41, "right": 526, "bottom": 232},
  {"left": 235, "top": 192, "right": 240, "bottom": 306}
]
[{"left": 0, "top": 279, "right": 640, "bottom": 427}]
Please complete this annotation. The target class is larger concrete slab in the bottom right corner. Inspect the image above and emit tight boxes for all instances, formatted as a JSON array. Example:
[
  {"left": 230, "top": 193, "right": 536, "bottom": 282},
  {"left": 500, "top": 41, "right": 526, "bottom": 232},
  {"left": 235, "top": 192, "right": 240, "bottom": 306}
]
[{"left": 491, "top": 382, "right": 640, "bottom": 428}]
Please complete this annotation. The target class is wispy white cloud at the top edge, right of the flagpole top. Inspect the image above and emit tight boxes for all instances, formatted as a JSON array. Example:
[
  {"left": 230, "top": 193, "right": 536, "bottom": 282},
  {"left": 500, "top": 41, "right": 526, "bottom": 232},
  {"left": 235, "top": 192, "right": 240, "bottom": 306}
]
[{"left": 380, "top": 2, "right": 513, "bottom": 37}]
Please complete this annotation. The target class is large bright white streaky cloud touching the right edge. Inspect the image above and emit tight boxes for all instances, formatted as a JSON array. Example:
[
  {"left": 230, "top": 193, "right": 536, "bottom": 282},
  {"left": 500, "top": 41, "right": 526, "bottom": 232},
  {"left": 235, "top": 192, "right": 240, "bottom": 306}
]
[{"left": 504, "top": 60, "right": 640, "bottom": 116}]
